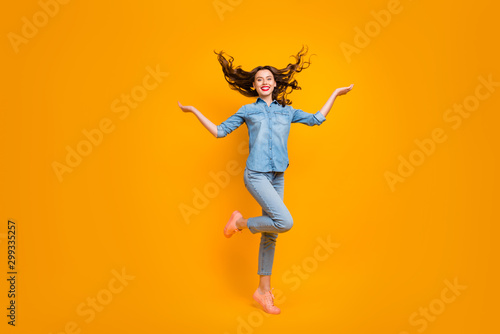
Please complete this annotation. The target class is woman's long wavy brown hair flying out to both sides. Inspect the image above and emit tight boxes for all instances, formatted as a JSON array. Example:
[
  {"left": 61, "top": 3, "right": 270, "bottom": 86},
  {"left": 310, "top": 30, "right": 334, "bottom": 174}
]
[{"left": 214, "top": 46, "right": 311, "bottom": 106}]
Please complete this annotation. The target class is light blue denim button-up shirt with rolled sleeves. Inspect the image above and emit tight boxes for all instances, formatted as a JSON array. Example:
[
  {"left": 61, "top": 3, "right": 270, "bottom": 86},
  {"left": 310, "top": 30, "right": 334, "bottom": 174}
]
[{"left": 217, "top": 97, "right": 326, "bottom": 172}]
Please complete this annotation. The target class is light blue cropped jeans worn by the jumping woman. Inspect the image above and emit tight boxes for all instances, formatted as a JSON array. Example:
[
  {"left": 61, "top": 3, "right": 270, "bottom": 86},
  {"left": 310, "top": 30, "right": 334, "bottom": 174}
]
[{"left": 243, "top": 168, "right": 293, "bottom": 275}]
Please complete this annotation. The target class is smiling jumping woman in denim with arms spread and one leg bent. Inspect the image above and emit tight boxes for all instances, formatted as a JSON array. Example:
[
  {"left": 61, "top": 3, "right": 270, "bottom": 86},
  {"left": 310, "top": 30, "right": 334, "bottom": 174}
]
[{"left": 178, "top": 48, "right": 353, "bottom": 314}]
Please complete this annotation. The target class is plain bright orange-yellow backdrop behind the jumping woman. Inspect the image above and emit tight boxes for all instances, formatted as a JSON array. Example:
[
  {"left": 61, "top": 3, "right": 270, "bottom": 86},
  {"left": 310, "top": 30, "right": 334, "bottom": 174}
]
[{"left": 0, "top": 0, "right": 500, "bottom": 334}]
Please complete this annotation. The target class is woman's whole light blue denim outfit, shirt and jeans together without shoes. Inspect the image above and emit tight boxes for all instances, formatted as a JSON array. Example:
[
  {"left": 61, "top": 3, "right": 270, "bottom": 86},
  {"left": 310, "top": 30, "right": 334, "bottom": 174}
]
[{"left": 217, "top": 97, "right": 326, "bottom": 275}]
